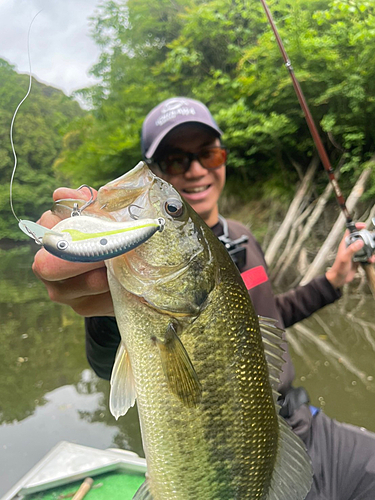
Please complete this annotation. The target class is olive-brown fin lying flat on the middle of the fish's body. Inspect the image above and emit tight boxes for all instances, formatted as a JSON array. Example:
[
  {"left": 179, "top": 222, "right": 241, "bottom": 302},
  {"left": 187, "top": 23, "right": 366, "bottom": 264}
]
[{"left": 156, "top": 323, "right": 202, "bottom": 407}]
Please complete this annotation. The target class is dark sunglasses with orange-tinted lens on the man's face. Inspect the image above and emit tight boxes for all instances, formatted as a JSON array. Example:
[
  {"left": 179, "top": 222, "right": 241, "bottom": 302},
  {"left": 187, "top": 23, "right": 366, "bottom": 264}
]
[{"left": 152, "top": 146, "right": 228, "bottom": 175}]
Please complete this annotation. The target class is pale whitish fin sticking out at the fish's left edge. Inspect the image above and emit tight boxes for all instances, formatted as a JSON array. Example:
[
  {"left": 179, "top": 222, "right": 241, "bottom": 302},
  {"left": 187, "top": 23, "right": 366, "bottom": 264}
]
[{"left": 109, "top": 342, "right": 136, "bottom": 420}]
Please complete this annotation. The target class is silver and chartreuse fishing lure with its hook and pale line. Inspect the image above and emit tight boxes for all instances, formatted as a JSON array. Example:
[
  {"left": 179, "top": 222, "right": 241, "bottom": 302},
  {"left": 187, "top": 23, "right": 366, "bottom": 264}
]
[{"left": 9, "top": 11, "right": 165, "bottom": 262}]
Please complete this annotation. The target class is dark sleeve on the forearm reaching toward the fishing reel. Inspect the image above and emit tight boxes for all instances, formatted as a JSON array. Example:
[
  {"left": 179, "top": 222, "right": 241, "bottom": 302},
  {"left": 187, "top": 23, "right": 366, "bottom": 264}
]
[{"left": 275, "top": 275, "right": 341, "bottom": 328}]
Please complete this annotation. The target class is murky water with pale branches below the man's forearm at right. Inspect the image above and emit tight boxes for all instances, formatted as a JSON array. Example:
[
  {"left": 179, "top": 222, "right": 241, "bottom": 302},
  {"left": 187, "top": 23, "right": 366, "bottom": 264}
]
[{"left": 288, "top": 294, "right": 375, "bottom": 431}]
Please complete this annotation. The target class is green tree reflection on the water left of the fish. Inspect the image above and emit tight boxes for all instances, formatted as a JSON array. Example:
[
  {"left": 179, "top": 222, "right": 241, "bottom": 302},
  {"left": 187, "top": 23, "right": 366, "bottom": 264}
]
[{"left": 0, "top": 246, "right": 88, "bottom": 424}]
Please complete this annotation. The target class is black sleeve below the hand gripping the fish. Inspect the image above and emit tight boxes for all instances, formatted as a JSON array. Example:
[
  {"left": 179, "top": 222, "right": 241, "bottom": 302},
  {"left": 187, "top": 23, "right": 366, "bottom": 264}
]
[{"left": 85, "top": 316, "right": 120, "bottom": 380}]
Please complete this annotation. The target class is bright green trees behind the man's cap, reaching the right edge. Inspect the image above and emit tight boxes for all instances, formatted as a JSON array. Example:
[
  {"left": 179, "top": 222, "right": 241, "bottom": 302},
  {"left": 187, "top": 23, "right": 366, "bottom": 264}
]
[{"left": 56, "top": 0, "right": 375, "bottom": 198}]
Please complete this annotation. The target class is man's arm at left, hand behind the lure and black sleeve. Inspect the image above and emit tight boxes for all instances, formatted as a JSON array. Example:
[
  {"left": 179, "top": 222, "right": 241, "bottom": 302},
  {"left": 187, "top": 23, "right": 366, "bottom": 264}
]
[{"left": 33, "top": 188, "right": 120, "bottom": 379}]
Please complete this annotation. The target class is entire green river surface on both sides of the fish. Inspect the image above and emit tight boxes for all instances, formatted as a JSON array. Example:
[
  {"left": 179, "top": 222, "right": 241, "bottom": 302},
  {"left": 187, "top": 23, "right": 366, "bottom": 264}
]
[{"left": 0, "top": 247, "right": 375, "bottom": 497}]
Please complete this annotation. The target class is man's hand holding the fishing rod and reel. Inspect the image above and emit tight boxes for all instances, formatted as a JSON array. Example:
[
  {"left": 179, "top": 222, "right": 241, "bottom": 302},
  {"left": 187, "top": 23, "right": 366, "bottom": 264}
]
[{"left": 326, "top": 222, "right": 375, "bottom": 288}]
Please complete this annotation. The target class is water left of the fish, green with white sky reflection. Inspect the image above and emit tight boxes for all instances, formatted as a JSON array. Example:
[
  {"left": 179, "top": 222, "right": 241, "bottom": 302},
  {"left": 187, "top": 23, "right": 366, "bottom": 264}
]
[{"left": 0, "top": 247, "right": 142, "bottom": 497}]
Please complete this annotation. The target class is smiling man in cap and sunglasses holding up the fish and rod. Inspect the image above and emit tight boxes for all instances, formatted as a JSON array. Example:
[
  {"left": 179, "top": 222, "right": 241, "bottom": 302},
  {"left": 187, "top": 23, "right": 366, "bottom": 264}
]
[{"left": 33, "top": 98, "right": 375, "bottom": 500}]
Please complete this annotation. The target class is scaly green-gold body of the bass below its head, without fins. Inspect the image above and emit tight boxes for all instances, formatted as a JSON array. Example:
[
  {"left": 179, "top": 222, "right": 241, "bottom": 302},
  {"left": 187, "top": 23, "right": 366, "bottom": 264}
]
[{"left": 111, "top": 254, "right": 278, "bottom": 500}]
